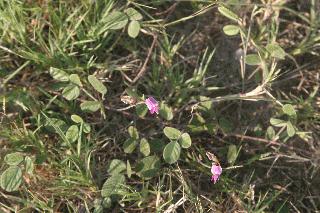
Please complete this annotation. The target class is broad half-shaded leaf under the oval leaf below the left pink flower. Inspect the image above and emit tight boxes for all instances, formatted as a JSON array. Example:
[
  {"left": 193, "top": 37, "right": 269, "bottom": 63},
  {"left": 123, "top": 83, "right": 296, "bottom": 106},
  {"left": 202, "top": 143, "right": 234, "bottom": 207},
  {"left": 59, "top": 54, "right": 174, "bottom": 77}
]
[{"left": 136, "top": 155, "right": 160, "bottom": 178}]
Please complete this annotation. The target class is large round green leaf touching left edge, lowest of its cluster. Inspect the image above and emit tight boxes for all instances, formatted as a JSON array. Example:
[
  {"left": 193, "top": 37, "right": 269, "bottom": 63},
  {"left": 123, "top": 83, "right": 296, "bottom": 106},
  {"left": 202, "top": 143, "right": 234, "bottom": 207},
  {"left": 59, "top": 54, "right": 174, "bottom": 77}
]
[{"left": 0, "top": 166, "right": 22, "bottom": 192}]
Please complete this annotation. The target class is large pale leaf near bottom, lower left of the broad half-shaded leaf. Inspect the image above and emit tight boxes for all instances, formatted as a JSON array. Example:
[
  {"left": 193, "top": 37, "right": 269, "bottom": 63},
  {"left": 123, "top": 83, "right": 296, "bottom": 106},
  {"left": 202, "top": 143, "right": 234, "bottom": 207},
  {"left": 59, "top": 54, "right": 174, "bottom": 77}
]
[{"left": 101, "top": 174, "right": 125, "bottom": 197}]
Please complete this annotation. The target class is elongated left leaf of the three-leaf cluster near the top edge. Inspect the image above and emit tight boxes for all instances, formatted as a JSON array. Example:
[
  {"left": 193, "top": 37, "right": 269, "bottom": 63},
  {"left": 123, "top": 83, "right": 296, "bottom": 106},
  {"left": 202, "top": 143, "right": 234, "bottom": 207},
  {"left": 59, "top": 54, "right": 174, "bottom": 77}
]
[{"left": 99, "top": 11, "right": 128, "bottom": 30}]
